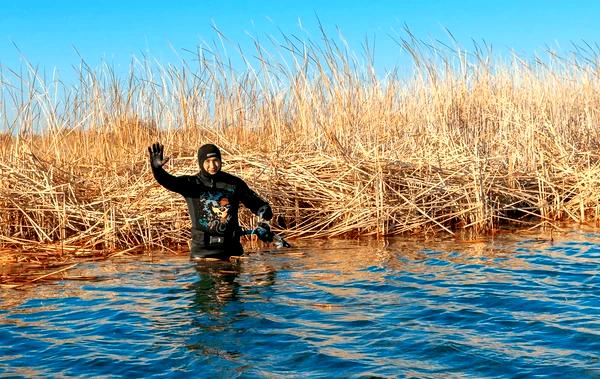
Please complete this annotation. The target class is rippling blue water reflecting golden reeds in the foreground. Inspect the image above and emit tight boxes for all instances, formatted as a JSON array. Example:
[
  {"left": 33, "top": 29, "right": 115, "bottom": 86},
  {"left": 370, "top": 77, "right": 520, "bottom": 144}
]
[{"left": 0, "top": 231, "right": 600, "bottom": 378}]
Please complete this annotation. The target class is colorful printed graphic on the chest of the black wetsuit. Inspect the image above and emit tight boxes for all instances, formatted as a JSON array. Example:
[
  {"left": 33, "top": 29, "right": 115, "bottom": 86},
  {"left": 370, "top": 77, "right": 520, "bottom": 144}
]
[{"left": 192, "top": 193, "right": 232, "bottom": 236}]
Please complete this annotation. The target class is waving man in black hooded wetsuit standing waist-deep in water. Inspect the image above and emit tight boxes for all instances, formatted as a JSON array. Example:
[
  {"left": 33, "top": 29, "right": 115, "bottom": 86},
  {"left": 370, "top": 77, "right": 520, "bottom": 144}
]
[{"left": 148, "top": 142, "right": 273, "bottom": 259}]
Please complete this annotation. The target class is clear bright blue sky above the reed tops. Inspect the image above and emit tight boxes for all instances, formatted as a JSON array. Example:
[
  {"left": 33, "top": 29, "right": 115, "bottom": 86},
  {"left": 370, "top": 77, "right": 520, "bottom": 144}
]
[{"left": 0, "top": 0, "right": 600, "bottom": 84}]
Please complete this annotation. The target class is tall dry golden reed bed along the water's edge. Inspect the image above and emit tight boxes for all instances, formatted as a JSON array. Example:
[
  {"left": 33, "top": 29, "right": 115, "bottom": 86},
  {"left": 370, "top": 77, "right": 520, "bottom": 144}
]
[{"left": 0, "top": 29, "right": 600, "bottom": 280}]
